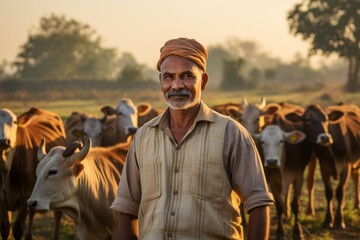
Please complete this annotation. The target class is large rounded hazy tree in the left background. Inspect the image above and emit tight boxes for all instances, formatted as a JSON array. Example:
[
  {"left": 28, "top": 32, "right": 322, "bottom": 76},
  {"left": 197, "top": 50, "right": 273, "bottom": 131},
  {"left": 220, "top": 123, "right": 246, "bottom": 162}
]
[{"left": 15, "top": 14, "right": 117, "bottom": 80}]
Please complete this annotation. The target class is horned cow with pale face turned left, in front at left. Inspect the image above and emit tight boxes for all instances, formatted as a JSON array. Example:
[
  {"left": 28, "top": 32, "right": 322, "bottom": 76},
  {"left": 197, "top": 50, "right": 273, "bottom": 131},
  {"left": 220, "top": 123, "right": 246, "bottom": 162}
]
[{"left": 27, "top": 139, "right": 129, "bottom": 240}]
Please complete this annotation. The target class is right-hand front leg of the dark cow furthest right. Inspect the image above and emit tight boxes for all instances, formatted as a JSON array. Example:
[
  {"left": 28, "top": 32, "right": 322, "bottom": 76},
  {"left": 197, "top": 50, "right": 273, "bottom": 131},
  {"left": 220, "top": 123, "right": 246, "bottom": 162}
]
[{"left": 334, "top": 164, "right": 351, "bottom": 229}]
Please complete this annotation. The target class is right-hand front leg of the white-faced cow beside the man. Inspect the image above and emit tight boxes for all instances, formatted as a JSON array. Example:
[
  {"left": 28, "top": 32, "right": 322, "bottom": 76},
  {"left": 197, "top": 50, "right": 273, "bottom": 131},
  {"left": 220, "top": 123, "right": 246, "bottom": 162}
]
[{"left": 291, "top": 176, "right": 304, "bottom": 240}]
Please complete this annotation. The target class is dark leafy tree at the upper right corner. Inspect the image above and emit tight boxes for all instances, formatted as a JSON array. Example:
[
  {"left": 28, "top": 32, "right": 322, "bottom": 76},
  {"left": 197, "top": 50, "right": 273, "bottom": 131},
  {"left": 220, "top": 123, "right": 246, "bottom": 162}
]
[{"left": 288, "top": 0, "right": 360, "bottom": 91}]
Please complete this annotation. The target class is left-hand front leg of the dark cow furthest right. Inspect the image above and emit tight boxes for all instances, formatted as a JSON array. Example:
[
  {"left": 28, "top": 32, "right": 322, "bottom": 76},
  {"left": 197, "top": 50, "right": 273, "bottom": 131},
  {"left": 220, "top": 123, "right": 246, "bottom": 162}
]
[{"left": 320, "top": 167, "right": 334, "bottom": 228}]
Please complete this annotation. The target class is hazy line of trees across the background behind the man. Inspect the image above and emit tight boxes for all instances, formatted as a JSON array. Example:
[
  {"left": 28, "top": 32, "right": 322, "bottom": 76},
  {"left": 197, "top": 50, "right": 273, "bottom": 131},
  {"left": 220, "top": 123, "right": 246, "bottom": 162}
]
[{"left": 0, "top": 0, "right": 360, "bottom": 91}]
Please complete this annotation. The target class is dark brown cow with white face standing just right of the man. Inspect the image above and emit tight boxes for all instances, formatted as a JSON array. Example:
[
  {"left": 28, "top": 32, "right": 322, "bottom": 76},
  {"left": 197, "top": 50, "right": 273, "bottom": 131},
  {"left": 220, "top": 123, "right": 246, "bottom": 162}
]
[{"left": 254, "top": 113, "right": 314, "bottom": 239}]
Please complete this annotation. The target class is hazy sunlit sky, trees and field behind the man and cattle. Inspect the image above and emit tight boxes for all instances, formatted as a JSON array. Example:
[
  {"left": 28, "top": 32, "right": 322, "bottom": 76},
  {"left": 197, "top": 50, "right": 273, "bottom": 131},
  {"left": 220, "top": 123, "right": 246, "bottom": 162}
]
[{"left": 0, "top": 0, "right": 360, "bottom": 239}]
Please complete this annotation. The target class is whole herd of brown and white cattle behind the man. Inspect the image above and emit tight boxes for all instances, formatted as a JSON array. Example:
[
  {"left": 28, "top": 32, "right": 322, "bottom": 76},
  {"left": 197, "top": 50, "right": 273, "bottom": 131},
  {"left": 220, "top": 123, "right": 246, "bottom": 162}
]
[{"left": 0, "top": 98, "right": 360, "bottom": 240}]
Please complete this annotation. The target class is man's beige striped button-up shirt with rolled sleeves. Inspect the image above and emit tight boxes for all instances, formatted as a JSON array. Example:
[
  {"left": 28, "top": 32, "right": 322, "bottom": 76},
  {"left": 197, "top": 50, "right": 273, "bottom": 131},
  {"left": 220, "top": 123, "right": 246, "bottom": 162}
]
[{"left": 111, "top": 103, "right": 273, "bottom": 240}]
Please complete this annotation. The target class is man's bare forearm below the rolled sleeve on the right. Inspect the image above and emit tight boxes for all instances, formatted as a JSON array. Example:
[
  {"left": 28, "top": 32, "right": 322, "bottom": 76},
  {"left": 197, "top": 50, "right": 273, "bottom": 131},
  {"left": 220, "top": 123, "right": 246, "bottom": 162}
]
[{"left": 248, "top": 206, "right": 270, "bottom": 240}]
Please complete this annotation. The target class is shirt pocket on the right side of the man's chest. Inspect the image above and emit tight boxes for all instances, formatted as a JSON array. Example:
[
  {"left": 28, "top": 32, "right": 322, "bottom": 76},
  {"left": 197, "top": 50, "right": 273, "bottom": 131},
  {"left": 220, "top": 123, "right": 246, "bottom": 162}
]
[{"left": 190, "top": 161, "right": 225, "bottom": 203}]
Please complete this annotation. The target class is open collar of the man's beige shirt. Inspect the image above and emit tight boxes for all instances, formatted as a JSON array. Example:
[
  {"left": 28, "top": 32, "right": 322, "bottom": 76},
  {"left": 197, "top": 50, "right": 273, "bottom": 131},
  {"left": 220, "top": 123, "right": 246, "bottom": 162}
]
[{"left": 149, "top": 101, "right": 215, "bottom": 129}]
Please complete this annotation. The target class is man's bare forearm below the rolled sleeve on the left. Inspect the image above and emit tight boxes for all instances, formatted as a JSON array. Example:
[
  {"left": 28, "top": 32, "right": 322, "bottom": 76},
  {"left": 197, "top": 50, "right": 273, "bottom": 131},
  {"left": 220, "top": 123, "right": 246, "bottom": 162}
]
[{"left": 115, "top": 213, "right": 139, "bottom": 240}]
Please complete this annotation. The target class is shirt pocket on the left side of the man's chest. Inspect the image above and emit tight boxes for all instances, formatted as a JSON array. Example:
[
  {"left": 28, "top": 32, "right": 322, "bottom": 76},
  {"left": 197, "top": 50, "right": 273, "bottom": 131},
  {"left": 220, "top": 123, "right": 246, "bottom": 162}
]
[{"left": 140, "top": 162, "right": 161, "bottom": 202}]
